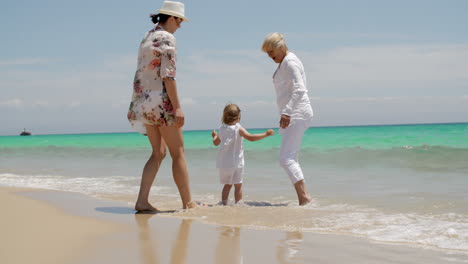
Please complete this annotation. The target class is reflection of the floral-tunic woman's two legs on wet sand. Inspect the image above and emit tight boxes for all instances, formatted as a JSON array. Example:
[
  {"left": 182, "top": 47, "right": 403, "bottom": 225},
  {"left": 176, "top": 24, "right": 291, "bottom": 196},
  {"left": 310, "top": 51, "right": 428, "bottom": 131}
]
[{"left": 135, "top": 214, "right": 193, "bottom": 264}]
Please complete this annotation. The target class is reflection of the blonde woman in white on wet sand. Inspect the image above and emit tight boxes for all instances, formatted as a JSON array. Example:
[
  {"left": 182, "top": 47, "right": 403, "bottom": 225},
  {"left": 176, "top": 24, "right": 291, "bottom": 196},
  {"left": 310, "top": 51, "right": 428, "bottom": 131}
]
[{"left": 276, "top": 231, "right": 303, "bottom": 264}]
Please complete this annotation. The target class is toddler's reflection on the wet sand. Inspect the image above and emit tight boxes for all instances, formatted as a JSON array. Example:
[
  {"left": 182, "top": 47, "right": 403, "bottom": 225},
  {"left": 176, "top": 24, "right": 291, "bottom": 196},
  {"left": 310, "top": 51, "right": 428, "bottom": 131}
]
[{"left": 214, "top": 226, "right": 243, "bottom": 264}]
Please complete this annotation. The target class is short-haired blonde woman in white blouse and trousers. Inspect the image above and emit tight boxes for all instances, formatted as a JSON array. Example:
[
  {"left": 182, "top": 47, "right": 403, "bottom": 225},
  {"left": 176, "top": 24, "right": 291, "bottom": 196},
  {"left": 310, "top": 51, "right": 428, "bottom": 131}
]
[{"left": 262, "top": 32, "right": 313, "bottom": 205}]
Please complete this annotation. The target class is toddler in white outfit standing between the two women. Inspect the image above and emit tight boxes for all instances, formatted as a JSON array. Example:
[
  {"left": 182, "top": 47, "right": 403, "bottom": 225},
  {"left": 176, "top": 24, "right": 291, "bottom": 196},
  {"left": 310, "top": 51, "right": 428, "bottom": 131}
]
[{"left": 211, "top": 104, "right": 274, "bottom": 205}]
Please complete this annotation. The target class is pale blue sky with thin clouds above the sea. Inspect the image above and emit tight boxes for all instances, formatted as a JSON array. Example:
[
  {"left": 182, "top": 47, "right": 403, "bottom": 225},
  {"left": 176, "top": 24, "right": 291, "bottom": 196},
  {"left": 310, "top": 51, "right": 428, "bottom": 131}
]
[{"left": 0, "top": 0, "right": 468, "bottom": 135}]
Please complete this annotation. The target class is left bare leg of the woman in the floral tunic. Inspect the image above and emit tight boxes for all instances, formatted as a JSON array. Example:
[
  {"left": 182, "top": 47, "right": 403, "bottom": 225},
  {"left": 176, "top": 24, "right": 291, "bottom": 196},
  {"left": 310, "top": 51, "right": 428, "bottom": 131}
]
[{"left": 135, "top": 125, "right": 166, "bottom": 211}]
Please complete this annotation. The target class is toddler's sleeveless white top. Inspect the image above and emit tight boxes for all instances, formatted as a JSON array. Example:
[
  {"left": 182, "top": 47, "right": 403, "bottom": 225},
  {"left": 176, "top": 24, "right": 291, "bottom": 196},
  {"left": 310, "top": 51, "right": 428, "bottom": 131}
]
[{"left": 216, "top": 123, "right": 244, "bottom": 169}]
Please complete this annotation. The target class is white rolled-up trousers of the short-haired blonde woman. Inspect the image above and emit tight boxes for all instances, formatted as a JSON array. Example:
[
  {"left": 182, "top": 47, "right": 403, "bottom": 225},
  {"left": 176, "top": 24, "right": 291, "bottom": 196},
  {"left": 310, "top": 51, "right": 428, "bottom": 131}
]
[{"left": 279, "top": 120, "right": 309, "bottom": 184}]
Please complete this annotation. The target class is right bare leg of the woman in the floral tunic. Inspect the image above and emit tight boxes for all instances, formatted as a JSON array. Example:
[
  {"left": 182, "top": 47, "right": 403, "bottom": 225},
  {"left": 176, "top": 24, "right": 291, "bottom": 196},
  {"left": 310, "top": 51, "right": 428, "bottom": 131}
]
[{"left": 159, "top": 126, "right": 197, "bottom": 209}]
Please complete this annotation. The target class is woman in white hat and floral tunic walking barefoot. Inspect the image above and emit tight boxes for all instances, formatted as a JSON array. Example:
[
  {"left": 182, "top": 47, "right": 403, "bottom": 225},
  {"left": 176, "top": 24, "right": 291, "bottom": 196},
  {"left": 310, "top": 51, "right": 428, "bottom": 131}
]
[{"left": 128, "top": 1, "right": 197, "bottom": 213}]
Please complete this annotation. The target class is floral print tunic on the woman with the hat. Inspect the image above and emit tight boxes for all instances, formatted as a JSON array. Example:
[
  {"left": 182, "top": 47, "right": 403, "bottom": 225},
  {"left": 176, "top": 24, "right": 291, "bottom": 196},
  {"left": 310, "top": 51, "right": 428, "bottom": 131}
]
[{"left": 127, "top": 25, "right": 176, "bottom": 135}]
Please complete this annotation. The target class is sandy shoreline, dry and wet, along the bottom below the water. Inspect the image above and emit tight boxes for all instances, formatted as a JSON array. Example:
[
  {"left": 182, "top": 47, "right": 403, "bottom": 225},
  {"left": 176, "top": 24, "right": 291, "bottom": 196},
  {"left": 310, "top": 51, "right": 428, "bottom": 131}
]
[{"left": 0, "top": 187, "right": 468, "bottom": 263}]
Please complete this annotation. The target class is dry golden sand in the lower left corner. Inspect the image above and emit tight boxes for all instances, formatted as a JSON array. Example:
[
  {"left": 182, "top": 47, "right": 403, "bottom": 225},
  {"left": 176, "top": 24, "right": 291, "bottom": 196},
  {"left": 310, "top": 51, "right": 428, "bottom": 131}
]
[{"left": 0, "top": 188, "right": 122, "bottom": 264}]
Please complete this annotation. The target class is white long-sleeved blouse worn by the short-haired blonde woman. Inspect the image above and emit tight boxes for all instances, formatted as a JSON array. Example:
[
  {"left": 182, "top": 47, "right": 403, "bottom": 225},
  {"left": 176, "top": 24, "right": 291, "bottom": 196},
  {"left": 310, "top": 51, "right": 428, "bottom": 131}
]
[{"left": 273, "top": 52, "right": 314, "bottom": 124}]
